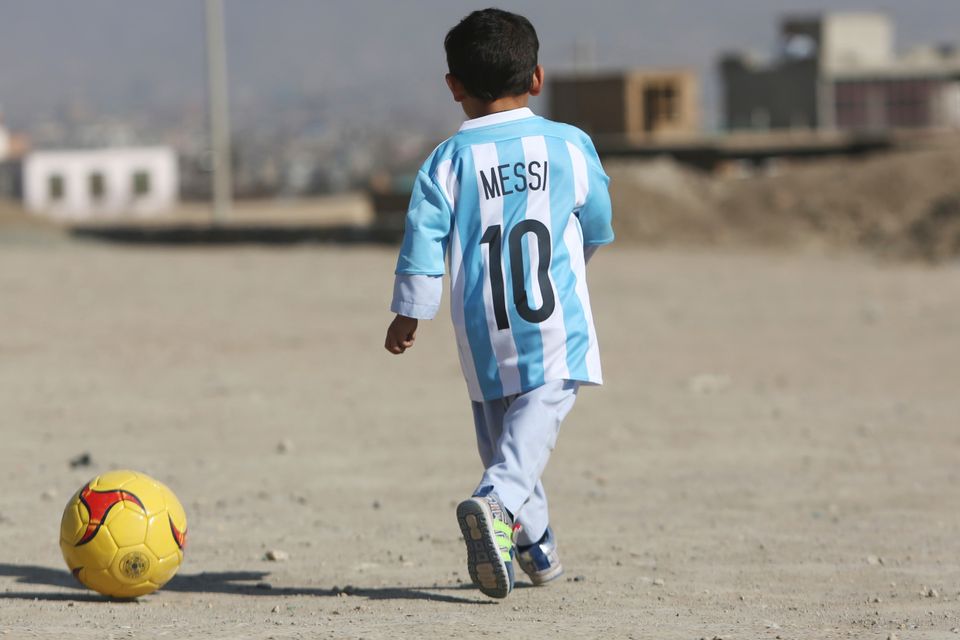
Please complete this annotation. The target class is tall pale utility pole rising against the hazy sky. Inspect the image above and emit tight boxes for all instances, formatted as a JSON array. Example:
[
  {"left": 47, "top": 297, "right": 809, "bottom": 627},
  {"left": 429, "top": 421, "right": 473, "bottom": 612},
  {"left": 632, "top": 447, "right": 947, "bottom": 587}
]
[{"left": 206, "top": 0, "right": 233, "bottom": 224}]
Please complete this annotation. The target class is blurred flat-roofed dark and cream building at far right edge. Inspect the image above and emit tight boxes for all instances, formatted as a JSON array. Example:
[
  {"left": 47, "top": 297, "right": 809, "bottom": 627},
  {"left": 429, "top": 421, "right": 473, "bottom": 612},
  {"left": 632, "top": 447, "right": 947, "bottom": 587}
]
[{"left": 720, "top": 12, "right": 960, "bottom": 131}]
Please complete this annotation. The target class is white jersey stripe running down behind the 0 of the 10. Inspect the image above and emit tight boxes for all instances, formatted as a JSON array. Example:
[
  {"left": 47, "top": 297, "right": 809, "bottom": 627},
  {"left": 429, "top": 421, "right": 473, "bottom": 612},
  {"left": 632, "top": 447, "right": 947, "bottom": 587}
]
[{"left": 521, "top": 136, "right": 570, "bottom": 381}]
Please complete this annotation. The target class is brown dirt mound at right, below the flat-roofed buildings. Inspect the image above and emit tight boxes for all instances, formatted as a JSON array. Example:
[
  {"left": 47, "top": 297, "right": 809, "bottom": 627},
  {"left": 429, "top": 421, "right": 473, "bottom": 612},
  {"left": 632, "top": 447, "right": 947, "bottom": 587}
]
[{"left": 609, "top": 150, "right": 960, "bottom": 261}]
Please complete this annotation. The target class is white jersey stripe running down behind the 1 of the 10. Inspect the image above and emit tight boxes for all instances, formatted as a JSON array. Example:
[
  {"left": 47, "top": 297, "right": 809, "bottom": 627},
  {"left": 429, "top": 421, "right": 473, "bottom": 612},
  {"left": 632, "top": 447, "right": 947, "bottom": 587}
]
[{"left": 470, "top": 143, "right": 520, "bottom": 396}]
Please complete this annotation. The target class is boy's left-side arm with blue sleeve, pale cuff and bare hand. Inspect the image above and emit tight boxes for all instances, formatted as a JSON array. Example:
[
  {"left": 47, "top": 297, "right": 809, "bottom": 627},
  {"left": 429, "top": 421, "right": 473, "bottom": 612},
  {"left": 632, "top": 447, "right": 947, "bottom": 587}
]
[{"left": 384, "top": 170, "right": 452, "bottom": 354}]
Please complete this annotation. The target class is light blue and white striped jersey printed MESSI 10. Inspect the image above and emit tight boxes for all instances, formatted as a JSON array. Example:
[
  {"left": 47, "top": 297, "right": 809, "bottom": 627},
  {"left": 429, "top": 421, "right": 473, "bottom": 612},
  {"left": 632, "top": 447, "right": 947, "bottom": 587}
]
[{"left": 394, "top": 108, "right": 613, "bottom": 401}]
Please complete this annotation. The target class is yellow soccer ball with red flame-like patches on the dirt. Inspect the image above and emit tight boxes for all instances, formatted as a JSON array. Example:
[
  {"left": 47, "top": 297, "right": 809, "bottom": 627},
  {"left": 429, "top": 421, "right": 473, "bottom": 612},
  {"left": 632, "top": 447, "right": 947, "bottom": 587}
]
[{"left": 60, "top": 471, "right": 187, "bottom": 598}]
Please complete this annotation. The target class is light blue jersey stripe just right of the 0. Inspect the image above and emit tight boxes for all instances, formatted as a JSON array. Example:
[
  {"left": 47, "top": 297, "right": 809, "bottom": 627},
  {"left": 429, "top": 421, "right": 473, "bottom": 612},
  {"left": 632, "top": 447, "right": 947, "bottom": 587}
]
[{"left": 546, "top": 136, "right": 590, "bottom": 380}]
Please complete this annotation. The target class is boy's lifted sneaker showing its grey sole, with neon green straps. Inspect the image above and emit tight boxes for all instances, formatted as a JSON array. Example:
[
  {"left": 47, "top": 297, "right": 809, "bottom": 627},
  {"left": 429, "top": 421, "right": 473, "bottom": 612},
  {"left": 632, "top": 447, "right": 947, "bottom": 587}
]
[{"left": 457, "top": 493, "right": 515, "bottom": 598}]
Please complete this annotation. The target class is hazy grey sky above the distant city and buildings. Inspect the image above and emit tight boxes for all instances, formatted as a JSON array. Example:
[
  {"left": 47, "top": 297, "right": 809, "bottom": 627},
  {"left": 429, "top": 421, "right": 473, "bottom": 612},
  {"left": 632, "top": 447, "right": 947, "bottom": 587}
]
[{"left": 0, "top": 0, "right": 960, "bottom": 131}]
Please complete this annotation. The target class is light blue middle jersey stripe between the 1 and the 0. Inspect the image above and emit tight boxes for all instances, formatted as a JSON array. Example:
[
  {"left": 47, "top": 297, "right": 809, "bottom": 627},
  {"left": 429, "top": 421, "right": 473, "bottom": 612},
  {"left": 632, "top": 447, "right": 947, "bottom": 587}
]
[{"left": 497, "top": 138, "right": 543, "bottom": 391}]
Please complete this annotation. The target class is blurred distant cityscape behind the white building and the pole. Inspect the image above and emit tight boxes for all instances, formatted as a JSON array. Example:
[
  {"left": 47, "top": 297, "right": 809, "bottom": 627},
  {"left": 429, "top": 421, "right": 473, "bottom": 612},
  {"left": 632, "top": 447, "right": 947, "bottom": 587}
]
[{"left": 6, "top": 100, "right": 442, "bottom": 200}]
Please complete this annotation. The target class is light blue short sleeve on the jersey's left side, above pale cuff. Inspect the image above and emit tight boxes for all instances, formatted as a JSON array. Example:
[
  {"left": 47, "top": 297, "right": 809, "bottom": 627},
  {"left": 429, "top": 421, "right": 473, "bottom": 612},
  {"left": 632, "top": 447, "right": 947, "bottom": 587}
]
[{"left": 396, "top": 169, "right": 453, "bottom": 276}]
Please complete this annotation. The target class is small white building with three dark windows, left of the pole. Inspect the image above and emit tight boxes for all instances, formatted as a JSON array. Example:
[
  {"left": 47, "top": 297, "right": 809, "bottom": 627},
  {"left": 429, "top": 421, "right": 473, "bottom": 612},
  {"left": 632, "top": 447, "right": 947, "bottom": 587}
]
[{"left": 23, "top": 147, "right": 179, "bottom": 220}]
